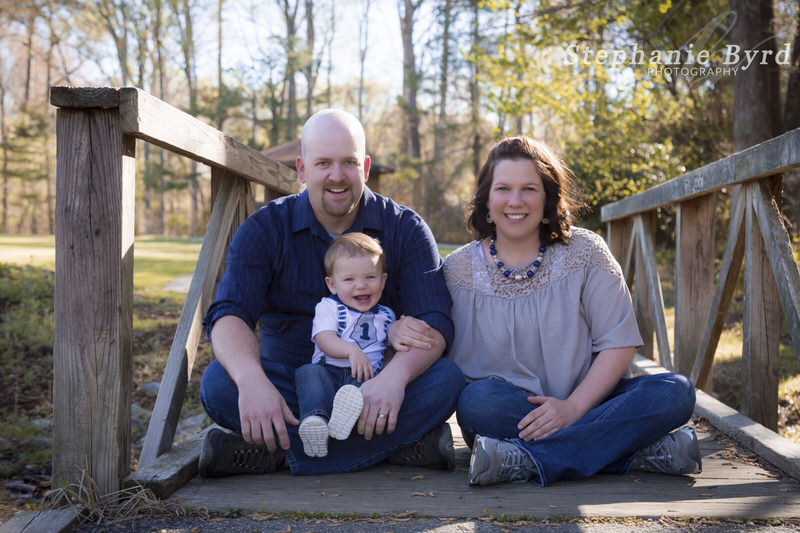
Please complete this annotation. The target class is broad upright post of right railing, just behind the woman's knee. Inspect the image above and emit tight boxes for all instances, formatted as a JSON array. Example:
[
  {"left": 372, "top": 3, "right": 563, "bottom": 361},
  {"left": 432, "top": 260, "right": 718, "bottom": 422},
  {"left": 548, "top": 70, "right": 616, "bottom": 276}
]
[{"left": 674, "top": 193, "right": 717, "bottom": 376}]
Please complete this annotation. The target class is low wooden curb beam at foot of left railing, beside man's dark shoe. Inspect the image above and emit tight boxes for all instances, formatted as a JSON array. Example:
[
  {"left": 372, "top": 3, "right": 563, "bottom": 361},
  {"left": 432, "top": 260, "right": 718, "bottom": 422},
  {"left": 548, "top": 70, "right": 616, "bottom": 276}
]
[{"left": 123, "top": 424, "right": 219, "bottom": 498}]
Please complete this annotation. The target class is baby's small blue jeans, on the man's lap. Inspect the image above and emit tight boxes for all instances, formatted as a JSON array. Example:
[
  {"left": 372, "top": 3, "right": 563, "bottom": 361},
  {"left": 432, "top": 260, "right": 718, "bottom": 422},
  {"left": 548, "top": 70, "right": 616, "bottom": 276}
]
[{"left": 294, "top": 363, "right": 361, "bottom": 422}]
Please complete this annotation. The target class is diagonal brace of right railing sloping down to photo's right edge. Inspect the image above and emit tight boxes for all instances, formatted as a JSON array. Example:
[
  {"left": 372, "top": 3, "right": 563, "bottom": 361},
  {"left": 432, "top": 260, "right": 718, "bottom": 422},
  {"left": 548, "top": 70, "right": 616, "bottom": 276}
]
[{"left": 753, "top": 183, "right": 800, "bottom": 357}]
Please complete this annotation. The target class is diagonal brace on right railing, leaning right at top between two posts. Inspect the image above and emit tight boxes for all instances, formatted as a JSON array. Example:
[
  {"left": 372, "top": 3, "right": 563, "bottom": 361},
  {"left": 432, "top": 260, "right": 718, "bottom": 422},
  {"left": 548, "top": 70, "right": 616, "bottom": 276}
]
[{"left": 691, "top": 193, "right": 745, "bottom": 389}]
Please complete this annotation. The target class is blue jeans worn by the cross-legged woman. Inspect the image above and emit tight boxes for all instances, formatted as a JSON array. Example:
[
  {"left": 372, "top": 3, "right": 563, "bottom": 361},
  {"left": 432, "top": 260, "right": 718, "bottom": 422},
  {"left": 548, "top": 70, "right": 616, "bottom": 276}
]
[{"left": 457, "top": 373, "right": 695, "bottom": 486}]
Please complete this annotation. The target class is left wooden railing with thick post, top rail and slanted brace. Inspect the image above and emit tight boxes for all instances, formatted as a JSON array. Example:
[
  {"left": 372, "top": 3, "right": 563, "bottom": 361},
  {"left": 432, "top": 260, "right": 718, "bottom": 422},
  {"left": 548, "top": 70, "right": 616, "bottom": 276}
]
[{"left": 50, "top": 87, "right": 300, "bottom": 494}]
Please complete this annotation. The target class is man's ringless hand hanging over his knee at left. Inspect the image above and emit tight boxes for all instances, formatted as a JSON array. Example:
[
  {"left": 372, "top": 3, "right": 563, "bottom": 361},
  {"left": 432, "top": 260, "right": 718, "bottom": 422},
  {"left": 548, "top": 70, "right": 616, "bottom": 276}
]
[{"left": 239, "top": 374, "right": 300, "bottom": 453}]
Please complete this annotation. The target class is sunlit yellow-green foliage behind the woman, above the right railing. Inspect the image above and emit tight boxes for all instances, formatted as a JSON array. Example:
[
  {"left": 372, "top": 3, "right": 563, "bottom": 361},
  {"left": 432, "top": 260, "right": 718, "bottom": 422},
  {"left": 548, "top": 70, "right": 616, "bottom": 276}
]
[{"left": 471, "top": 0, "right": 731, "bottom": 228}]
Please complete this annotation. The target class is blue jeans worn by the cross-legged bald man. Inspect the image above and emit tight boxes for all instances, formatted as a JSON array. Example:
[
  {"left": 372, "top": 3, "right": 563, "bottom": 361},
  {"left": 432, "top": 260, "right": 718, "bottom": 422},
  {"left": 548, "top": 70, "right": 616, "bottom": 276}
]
[{"left": 200, "top": 354, "right": 464, "bottom": 475}]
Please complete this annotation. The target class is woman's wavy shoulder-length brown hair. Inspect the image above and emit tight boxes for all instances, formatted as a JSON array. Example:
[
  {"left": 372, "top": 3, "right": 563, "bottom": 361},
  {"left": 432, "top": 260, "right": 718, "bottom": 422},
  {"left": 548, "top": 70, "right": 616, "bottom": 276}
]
[{"left": 467, "top": 136, "right": 586, "bottom": 246}]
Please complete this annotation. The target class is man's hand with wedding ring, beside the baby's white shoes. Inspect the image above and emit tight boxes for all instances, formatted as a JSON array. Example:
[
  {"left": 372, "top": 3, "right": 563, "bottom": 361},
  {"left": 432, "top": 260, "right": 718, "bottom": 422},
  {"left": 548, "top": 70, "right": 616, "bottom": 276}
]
[{"left": 357, "top": 370, "right": 406, "bottom": 440}]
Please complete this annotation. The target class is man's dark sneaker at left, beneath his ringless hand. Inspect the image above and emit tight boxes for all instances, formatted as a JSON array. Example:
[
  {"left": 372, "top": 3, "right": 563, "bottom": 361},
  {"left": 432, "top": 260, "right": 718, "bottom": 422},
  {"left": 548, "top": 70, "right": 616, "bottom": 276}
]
[{"left": 197, "top": 428, "right": 286, "bottom": 477}]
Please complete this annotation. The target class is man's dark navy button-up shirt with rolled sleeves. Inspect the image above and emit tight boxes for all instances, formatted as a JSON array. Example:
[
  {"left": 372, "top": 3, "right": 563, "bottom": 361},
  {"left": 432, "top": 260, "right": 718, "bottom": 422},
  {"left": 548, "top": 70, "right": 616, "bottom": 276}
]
[{"left": 203, "top": 188, "right": 453, "bottom": 366}]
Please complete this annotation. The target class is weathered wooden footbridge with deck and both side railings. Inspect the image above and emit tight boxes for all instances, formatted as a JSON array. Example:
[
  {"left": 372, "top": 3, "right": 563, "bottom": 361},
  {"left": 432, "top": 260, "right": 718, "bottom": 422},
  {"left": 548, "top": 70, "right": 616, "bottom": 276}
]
[{"left": 9, "top": 87, "right": 800, "bottom": 528}]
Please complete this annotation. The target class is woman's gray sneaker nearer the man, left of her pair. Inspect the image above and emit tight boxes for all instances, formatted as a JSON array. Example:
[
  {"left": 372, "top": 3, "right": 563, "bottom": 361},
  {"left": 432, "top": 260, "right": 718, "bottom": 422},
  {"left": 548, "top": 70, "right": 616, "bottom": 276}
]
[{"left": 469, "top": 435, "right": 539, "bottom": 485}]
